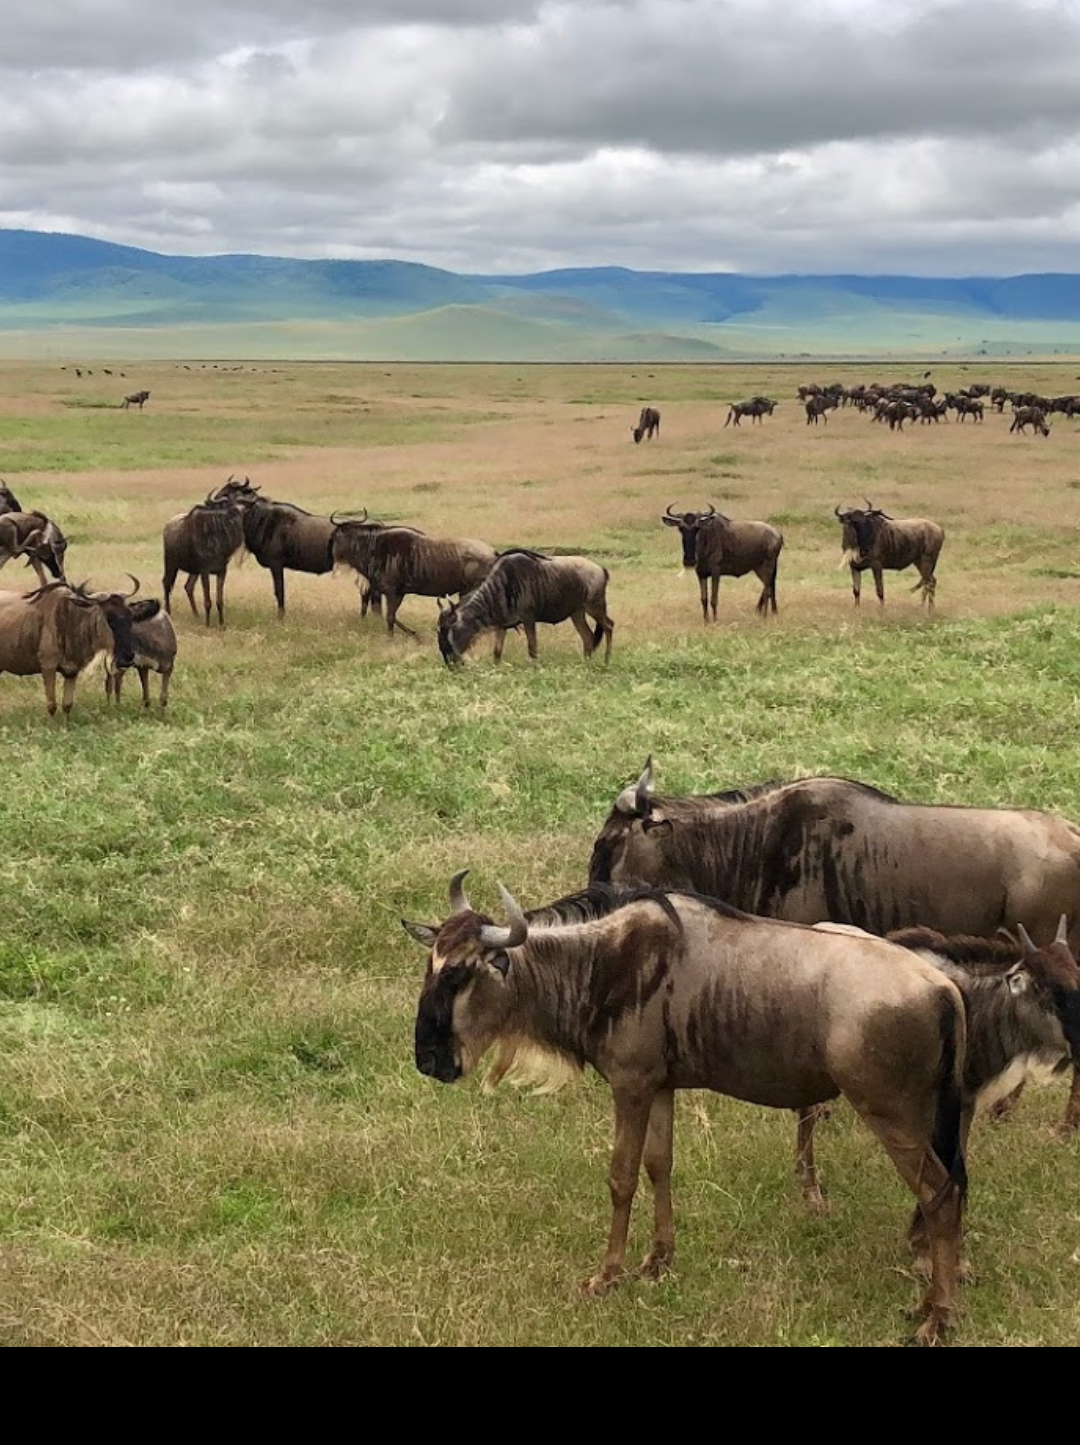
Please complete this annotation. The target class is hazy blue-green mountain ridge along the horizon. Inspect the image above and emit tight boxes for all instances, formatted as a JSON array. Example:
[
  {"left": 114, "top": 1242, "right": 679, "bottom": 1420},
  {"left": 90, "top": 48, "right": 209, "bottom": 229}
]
[{"left": 0, "top": 230, "right": 1080, "bottom": 360}]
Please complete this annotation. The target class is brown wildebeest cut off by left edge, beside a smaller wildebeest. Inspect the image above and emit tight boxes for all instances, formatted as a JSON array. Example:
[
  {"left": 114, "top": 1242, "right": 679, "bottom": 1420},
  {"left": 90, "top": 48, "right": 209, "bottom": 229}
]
[{"left": 0, "top": 574, "right": 139, "bottom": 717}]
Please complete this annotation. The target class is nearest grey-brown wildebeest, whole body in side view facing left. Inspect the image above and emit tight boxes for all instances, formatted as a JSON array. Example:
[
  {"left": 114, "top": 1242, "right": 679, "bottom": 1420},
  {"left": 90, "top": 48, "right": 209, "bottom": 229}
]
[{"left": 405, "top": 874, "right": 966, "bottom": 1344}]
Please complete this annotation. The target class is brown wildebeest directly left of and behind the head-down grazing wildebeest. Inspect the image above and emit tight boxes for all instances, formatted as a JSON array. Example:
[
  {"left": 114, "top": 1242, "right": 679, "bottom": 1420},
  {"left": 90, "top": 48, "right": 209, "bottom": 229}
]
[{"left": 330, "top": 513, "right": 496, "bottom": 637}]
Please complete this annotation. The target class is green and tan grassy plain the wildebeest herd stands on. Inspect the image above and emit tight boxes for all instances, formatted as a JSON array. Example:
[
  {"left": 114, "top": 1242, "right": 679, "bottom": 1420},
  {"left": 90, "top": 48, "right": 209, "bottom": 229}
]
[{"left": 0, "top": 357, "right": 1080, "bottom": 1345}]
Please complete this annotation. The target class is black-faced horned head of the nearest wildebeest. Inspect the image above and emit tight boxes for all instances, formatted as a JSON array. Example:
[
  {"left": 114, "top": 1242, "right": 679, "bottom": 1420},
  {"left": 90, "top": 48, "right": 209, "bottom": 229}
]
[{"left": 402, "top": 870, "right": 529, "bottom": 1084}]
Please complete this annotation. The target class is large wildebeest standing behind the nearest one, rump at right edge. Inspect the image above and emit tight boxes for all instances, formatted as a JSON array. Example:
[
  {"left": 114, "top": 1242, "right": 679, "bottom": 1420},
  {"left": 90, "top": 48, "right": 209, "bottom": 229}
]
[{"left": 588, "top": 759, "right": 1080, "bottom": 1129}]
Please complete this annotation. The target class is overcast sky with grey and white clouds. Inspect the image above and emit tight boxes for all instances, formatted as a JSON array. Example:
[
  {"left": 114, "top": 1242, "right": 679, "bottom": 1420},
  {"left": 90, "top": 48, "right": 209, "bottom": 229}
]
[{"left": 0, "top": 0, "right": 1080, "bottom": 276}]
